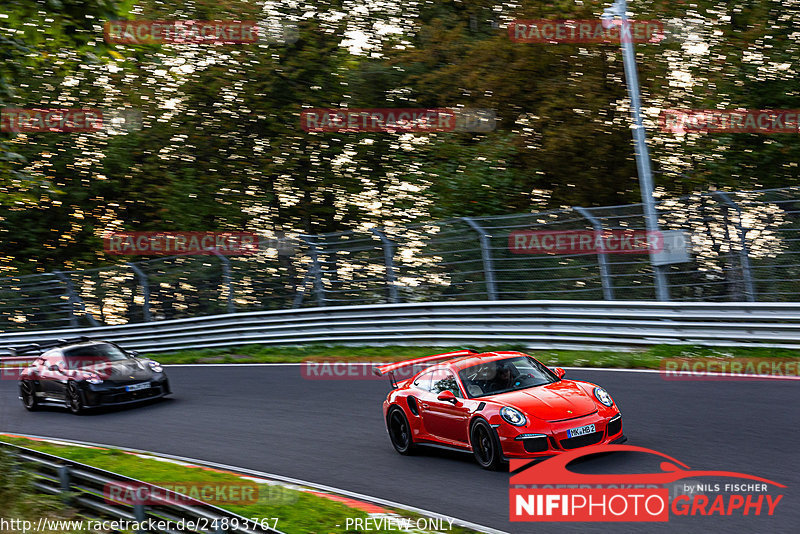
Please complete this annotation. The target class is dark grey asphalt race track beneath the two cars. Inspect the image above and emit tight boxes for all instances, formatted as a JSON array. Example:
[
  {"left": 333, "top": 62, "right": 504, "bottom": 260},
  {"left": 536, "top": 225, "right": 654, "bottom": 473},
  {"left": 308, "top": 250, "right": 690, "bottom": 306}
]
[{"left": 0, "top": 366, "right": 800, "bottom": 533}]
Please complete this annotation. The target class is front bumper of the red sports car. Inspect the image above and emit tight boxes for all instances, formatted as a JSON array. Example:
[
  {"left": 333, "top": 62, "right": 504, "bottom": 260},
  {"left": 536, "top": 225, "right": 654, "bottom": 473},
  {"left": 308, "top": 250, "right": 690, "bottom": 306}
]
[{"left": 492, "top": 413, "right": 626, "bottom": 458}]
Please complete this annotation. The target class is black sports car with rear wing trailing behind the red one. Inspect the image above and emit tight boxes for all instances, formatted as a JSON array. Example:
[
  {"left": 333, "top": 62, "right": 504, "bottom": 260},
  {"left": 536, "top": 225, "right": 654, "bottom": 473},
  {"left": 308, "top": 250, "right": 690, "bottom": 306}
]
[{"left": 16, "top": 338, "right": 171, "bottom": 413}]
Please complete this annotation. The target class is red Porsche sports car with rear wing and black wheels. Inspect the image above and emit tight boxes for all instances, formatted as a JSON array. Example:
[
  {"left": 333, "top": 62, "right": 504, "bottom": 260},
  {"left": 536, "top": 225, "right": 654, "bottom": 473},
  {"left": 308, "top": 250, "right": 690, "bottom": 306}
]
[{"left": 375, "top": 350, "right": 626, "bottom": 469}]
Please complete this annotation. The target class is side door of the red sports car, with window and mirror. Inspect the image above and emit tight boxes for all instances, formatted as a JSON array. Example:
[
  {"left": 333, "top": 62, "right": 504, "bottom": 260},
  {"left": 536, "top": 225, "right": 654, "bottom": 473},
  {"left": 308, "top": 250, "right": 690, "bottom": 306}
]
[{"left": 421, "top": 369, "right": 470, "bottom": 447}]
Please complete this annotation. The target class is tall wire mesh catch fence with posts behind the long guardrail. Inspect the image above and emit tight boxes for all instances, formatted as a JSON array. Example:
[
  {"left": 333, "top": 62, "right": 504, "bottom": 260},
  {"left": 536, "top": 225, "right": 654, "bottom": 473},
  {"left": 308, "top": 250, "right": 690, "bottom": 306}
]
[{"left": 0, "top": 187, "right": 800, "bottom": 331}]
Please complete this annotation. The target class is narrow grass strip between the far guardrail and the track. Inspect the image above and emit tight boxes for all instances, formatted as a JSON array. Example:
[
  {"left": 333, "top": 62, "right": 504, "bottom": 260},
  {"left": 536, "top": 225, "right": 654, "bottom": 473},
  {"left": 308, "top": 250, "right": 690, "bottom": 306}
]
[{"left": 147, "top": 344, "right": 800, "bottom": 369}]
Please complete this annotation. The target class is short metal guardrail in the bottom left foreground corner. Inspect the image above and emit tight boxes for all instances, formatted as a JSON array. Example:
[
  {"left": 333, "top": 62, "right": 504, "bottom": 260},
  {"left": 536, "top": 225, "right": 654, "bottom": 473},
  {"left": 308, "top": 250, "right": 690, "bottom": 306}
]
[{"left": 0, "top": 442, "right": 282, "bottom": 534}]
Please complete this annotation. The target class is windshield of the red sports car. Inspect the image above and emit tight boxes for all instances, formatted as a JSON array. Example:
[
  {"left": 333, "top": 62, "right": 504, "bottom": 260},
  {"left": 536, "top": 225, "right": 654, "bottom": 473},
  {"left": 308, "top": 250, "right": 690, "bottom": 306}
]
[{"left": 458, "top": 356, "right": 558, "bottom": 398}]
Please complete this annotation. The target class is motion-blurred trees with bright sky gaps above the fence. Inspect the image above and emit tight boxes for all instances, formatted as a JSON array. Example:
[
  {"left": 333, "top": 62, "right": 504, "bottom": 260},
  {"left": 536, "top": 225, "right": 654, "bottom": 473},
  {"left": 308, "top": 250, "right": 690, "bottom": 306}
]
[{"left": 0, "top": 0, "right": 800, "bottom": 275}]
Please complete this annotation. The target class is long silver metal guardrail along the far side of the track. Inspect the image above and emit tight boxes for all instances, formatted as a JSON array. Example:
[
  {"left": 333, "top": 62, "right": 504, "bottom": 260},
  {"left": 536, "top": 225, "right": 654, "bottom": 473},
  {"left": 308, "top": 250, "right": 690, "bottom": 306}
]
[{"left": 0, "top": 301, "right": 800, "bottom": 353}]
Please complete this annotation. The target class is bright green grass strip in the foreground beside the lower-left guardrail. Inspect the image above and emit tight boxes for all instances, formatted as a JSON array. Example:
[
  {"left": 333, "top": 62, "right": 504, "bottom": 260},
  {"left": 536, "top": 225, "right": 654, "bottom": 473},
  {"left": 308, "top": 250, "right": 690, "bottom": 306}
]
[{"left": 0, "top": 435, "right": 473, "bottom": 534}]
